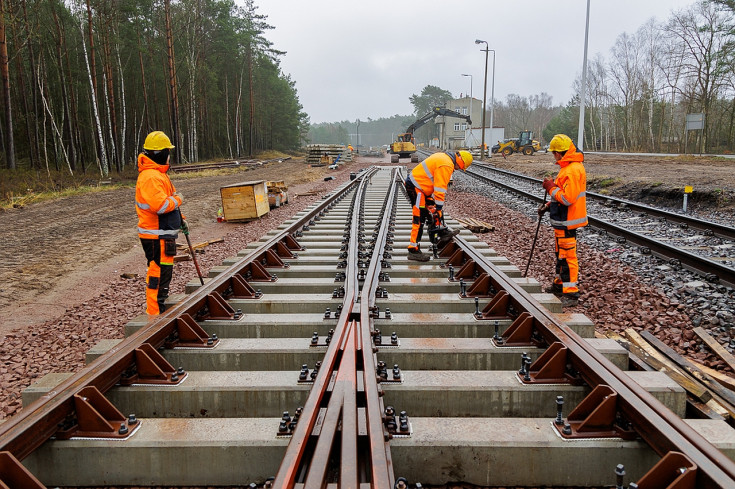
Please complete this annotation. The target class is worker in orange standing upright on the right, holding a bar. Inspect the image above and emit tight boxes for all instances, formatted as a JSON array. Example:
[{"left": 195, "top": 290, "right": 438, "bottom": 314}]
[{"left": 538, "top": 134, "right": 587, "bottom": 307}]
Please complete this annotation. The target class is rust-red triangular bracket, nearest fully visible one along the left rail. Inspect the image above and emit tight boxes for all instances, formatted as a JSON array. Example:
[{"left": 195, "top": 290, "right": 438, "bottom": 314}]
[{"left": 54, "top": 386, "right": 141, "bottom": 440}]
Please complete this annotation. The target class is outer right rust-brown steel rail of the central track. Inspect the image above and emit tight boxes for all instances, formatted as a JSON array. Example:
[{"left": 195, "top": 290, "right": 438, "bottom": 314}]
[{"left": 455, "top": 236, "right": 735, "bottom": 489}]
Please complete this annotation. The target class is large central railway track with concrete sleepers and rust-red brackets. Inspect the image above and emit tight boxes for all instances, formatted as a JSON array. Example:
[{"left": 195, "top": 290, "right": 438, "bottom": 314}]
[{"left": 0, "top": 167, "right": 735, "bottom": 489}]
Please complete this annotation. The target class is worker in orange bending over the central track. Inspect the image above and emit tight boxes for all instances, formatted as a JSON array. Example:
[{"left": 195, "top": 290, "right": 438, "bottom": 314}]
[{"left": 406, "top": 151, "right": 472, "bottom": 261}]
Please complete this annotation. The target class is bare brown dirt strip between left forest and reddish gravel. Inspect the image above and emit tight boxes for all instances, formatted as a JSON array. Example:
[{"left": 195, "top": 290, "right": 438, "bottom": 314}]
[{"left": 0, "top": 159, "right": 340, "bottom": 337}]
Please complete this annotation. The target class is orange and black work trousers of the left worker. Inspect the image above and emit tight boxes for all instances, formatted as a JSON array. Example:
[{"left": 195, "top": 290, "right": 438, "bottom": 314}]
[{"left": 140, "top": 238, "right": 176, "bottom": 315}]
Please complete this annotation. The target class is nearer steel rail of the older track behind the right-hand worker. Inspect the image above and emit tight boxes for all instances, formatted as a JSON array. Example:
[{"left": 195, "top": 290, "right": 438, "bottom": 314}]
[{"left": 466, "top": 168, "right": 735, "bottom": 286}]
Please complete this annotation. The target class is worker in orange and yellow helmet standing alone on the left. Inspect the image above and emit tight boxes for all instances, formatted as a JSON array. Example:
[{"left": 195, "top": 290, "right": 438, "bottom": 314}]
[{"left": 135, "top": 131, "right": 183, "bottom": 315}]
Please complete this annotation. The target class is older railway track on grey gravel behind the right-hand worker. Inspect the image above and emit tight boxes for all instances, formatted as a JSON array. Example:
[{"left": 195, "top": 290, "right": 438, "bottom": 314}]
[{"left": 466, "top": 163, "right": 735, "bottom": 287}]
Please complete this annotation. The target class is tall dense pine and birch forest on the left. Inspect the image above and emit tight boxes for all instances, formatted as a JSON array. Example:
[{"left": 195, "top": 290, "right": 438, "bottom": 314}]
[{"left": 0, "top": 0, "right": 308, "bottom": 176}]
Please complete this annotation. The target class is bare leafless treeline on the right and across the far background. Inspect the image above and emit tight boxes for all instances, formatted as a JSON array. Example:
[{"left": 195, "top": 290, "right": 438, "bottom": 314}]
[{"left": 309, "top": 0, "right": 735, "bottom": 153}]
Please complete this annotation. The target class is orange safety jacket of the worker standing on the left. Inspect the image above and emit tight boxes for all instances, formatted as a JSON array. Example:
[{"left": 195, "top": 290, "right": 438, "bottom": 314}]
[{"left": 135, "top": 153, "right": 181, "bottom": 239}]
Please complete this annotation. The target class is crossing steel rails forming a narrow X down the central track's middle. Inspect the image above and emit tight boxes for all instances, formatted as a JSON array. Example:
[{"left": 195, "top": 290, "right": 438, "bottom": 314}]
[{"left": 274, "top": 166, "right": 397, "bottom": 489}]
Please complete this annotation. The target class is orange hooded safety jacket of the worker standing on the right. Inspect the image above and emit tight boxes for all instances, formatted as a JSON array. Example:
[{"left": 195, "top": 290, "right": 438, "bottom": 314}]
[{"left": 549, "top": 144, "right": 587, "bottom": 229}]
